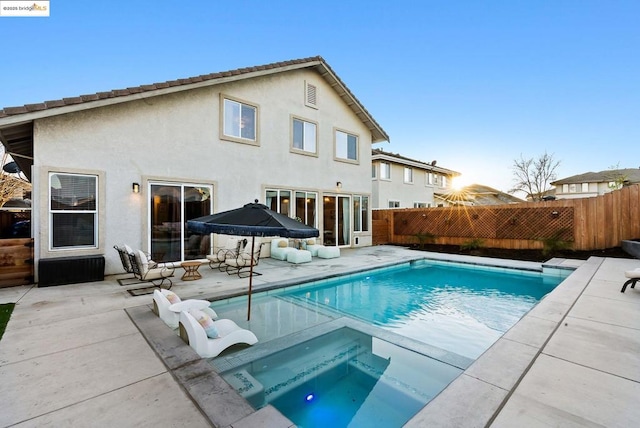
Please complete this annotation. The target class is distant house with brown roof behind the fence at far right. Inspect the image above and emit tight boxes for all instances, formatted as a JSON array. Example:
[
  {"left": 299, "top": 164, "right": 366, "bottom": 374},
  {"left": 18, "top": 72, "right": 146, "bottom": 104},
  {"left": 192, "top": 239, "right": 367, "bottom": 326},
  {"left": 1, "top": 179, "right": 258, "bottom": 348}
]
[{"left": 551, "top": 168, "right": 640, "bottom": 199}]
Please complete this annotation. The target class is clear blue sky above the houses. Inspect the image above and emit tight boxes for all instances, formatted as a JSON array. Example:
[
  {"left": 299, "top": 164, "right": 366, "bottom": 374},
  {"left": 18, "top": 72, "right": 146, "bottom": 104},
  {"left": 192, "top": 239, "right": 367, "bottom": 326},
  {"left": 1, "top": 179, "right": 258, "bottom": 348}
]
[{"left": 0, "top": 0, "right": 640, "bottom": 191}]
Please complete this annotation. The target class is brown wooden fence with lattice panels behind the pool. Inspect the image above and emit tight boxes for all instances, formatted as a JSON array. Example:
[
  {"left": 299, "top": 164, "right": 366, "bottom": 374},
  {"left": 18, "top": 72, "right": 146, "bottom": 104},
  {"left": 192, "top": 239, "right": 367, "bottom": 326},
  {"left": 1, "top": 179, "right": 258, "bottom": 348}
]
[{"left": 373, "top": 184, "right": 640, "bottom": 250}]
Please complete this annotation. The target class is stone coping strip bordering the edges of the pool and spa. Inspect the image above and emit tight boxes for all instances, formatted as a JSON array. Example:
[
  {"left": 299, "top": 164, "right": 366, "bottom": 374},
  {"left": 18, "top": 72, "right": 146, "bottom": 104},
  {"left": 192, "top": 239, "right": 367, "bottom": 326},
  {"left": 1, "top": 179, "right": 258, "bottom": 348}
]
[{"left": 125, "top": 253, "right": 584, "bottom": 428}]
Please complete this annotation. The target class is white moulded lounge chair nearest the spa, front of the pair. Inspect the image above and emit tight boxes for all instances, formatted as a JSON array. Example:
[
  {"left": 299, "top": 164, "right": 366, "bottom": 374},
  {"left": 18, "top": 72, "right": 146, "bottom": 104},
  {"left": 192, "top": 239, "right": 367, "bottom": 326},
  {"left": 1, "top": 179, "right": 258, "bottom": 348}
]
[{"left": 179, "top": 311, "right": 258, "bottom": 358}]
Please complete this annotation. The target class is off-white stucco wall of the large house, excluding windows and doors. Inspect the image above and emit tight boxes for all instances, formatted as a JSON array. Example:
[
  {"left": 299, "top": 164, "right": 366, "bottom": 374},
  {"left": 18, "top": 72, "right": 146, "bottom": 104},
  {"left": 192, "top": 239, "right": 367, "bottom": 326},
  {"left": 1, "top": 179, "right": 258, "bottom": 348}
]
[{"left": 33, "top": 70, "right": 371, "bottom": 273}]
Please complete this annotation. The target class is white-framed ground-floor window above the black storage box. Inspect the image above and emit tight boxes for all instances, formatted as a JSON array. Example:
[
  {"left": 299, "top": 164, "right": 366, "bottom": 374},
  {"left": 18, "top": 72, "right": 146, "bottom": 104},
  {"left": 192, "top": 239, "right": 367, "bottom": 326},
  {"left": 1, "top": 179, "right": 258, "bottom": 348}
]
[{"left": 49, "top": 173, "right": 98, "bottom": 249}]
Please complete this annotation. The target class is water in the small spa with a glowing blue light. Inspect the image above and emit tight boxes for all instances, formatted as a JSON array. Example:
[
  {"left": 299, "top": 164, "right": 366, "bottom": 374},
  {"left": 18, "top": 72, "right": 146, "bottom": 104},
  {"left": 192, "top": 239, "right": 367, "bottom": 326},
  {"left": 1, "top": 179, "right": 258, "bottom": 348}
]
[{"left": 222, "top": 328, "right": 462, "bottom": 427}]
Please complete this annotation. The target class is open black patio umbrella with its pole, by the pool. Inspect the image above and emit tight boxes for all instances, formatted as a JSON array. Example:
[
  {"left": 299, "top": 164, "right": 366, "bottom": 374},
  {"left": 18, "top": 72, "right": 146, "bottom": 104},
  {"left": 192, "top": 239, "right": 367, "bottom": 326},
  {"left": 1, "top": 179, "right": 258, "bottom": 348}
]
[{"left": 187, "top": 199, "right": 320, "bottom": 321}]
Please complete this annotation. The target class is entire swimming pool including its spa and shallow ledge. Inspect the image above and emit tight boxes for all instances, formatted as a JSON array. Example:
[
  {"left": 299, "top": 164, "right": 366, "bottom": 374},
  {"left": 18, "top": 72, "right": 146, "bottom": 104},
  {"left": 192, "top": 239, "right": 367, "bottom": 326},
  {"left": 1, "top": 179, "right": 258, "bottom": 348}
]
[{"left": 212, "top": 260, "right": 570, "bottom": 426}]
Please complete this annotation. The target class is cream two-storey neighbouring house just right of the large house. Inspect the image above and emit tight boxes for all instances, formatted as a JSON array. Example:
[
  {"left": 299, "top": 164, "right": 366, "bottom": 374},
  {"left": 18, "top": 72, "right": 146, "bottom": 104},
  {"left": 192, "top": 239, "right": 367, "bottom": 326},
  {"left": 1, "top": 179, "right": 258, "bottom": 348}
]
[{"left": 371, "top": 149, "right": 460, "bottom": 209}]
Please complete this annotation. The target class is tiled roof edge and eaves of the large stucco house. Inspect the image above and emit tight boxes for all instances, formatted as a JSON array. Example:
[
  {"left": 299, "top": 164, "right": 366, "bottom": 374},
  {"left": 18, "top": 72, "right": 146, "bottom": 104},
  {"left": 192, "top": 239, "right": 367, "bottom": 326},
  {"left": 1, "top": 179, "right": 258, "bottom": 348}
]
[{"left": 0, "top": 56, "right": 389, "bottom": 180}]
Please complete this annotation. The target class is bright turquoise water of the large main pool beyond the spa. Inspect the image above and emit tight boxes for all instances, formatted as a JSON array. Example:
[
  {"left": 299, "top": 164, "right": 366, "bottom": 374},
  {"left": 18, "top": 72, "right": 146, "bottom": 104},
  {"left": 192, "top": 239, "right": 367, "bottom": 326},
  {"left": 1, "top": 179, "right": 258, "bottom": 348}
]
[{"left": 282, "top": 263, "right": 563, "bottom": 359}]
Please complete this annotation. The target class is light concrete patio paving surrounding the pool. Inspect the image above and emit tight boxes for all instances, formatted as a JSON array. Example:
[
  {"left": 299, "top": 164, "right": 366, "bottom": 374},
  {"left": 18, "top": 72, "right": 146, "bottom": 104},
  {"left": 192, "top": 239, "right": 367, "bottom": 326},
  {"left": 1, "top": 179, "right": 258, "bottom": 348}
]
[{"left": 0, "top": 246, "right": 640, "bottom": 428}]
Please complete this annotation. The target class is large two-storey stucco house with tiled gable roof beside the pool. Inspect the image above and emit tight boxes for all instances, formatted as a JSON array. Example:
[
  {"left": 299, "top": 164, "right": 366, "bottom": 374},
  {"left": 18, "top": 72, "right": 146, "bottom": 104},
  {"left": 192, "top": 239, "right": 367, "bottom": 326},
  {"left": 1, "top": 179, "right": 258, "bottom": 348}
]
[{"left": 0, "top": 57, "right": 389, "bottom": 274}]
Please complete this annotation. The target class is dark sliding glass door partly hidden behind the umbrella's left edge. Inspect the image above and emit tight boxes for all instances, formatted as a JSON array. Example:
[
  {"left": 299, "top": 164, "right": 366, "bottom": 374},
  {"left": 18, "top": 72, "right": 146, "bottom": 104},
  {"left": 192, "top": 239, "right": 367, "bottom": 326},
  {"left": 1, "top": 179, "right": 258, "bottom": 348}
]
[{"left": 149, "top": 183, "right": 213, "bottom": 262}]
